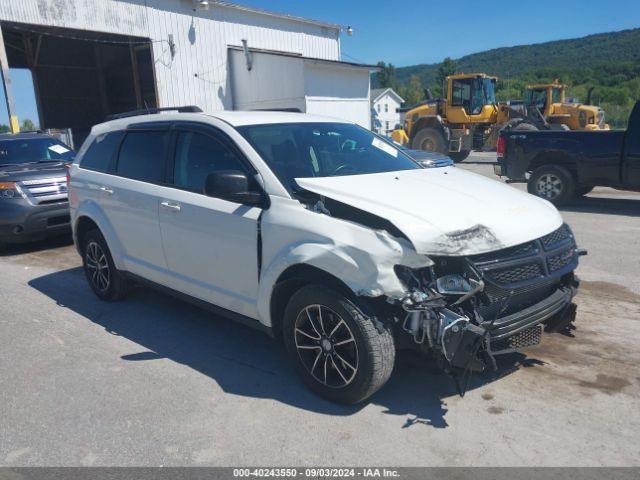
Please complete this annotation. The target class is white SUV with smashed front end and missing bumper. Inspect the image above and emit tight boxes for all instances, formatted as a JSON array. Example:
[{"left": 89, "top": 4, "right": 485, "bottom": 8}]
[{"left": 69, "top": 107, "right": 580, "bottom": 403}]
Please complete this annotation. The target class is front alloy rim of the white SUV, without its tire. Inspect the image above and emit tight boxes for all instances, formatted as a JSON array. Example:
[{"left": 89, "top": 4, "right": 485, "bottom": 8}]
[{"left": 295, "top": 305, "right": 358, "bottom": 388}]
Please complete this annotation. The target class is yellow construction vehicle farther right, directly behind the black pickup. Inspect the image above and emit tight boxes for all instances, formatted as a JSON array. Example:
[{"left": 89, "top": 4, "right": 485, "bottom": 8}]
[{"left": 524, "top": 79, "right": 609, "bottom": 130}]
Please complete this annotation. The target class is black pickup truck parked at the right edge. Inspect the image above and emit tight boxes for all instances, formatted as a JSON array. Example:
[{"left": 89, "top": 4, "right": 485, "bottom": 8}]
[{"left": 494, "top": 101, "right": 640, "bottom": 205}]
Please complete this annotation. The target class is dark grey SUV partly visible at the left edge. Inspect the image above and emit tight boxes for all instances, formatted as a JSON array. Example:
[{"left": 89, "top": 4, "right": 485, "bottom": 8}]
[{"left": 0, "top": 133, "right": 75, "bottom": 248}]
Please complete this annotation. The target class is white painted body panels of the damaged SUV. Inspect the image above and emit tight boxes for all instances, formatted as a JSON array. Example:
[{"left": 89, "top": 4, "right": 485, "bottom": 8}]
[{"left": 69, "top": 112, "right": 562, "bottom": 326}]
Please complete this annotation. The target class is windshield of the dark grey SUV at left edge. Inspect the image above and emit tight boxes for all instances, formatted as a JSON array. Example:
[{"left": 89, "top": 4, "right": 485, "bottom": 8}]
[{"left": 0, "top": 137, "right": 75, "bottom": 165}]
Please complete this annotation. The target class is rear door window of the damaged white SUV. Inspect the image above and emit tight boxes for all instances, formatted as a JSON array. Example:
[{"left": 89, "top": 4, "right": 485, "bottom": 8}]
[{"left": 116, "top": 132, "right": 168, "bottom": 183}]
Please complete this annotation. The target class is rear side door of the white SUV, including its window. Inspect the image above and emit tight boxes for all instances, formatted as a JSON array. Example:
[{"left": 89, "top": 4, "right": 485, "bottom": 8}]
[{"left": 105, "top": 125, "right": 170, "bottom": 283}]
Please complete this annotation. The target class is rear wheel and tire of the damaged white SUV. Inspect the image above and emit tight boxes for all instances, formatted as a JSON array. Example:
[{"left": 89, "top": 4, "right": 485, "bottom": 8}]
[{"left": 82, "top": 229, "right": 129, "bottom": 300}]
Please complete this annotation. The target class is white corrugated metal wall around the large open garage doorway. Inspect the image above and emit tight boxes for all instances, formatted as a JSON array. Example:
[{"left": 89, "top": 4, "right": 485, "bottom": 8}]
[{"left": 0, "top": 0, "right": 340, "bottom": 111}]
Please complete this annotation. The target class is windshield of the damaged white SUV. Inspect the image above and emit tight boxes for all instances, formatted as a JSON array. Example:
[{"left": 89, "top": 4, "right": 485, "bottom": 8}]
[{"left": 238, "top": 123, "right": 421, "bottom": 191}]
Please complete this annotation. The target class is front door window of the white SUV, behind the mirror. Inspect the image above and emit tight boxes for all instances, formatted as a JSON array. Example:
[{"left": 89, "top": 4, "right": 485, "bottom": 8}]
[{"left": 173, "top": 132, "right": 245, "bottom": 193}]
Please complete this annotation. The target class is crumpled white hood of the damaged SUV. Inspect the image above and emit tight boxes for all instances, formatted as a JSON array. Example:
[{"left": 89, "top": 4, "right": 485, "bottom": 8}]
[{"left": 296, "top": 167, "right": 562, "bottom": 255}]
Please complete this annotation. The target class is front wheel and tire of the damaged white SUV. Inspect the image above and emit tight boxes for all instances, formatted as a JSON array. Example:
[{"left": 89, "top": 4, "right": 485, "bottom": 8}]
[{"left": 282, "top": 285, "right": 395, "bottom": 404}]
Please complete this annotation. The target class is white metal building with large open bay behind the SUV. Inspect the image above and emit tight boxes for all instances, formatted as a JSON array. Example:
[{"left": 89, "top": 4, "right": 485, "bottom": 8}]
[{"left": 0, "top": 0, "right": 375, "bottom": 141}]
